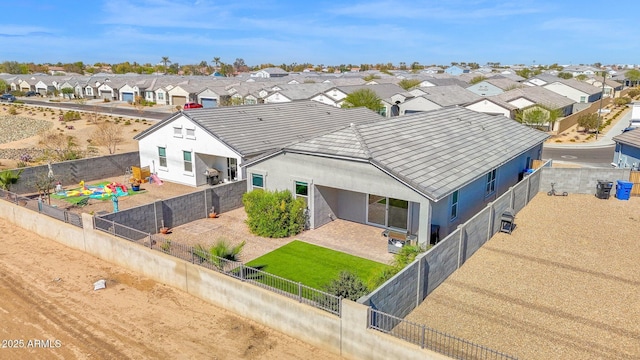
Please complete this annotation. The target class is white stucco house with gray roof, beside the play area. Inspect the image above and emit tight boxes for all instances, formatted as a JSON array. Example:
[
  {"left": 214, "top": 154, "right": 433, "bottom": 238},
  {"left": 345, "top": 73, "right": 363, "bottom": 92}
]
[{"left": 134, "top": 100, "right": 383, "bottom": 186}]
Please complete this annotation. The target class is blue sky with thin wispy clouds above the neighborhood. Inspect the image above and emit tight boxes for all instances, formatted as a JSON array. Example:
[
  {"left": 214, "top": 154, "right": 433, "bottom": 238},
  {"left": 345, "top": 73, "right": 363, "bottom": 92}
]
[{"left": 0, "top": 0, "right": 640, "bottom": 66}]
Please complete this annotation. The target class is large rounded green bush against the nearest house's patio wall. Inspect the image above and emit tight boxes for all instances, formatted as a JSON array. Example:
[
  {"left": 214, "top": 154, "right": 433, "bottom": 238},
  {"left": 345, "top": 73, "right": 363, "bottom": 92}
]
[{"left": 242, "top": 190, "right": 306, "bottom": 238}]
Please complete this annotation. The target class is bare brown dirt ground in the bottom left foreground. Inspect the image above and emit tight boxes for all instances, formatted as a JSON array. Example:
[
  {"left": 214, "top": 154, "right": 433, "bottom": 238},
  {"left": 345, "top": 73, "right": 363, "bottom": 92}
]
[{"left": 0, "top": 219, "right": 340, "bottom": 359}]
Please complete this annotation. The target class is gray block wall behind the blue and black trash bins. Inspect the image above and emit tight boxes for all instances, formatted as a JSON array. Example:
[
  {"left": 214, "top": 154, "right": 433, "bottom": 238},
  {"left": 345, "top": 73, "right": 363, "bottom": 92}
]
[{"left": 539, "top": 167, "right": 631, "bottom": 196}]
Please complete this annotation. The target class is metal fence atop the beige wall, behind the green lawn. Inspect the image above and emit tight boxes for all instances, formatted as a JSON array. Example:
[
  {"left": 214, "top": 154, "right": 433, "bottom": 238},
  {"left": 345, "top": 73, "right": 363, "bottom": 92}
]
[{"left": 93, "top": 216, "right": 342, "bottom": 316}]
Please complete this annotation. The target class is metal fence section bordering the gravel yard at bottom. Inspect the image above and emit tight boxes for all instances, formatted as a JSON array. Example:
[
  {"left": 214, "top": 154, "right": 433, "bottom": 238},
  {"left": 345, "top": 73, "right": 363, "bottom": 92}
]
[{"left": 368, "top": 308, "right": 517, "bottom": 360}]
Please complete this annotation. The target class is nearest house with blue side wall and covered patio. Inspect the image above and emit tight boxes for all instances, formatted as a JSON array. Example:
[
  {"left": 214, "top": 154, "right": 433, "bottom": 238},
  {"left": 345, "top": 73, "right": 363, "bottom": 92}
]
[{"left": 242, "top": 107, "right": 548, "bottom": 245}]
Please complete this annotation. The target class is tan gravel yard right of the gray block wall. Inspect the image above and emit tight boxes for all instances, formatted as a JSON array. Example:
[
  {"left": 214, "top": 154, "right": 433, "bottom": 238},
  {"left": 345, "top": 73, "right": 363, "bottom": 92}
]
[{"left": 407, "top": 193, "right": 640, "bottom": 359}]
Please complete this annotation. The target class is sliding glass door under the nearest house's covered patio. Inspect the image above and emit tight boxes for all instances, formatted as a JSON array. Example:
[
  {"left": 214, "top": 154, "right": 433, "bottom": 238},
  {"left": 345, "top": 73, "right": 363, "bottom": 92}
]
[{"left": 367, "top": 194, "right": 409, "bottom": 230}]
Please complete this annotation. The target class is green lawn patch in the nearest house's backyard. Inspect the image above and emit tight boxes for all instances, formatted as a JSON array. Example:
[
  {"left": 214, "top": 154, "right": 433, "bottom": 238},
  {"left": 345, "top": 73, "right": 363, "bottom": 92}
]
[{"left": 246, "top": 240, "right": 389, "bottom": 289}]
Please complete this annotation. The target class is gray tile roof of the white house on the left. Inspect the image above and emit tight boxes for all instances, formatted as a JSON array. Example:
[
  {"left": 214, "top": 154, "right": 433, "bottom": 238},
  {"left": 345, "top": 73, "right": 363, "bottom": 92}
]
[{"left": 134, "top": 100, "right": 384, "bottom": 157}]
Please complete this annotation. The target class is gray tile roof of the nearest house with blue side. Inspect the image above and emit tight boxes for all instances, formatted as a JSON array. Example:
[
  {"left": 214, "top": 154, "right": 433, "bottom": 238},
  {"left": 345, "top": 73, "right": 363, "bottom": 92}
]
[{"left": 284, "top": 107, "right": 548, "bottom": 201}]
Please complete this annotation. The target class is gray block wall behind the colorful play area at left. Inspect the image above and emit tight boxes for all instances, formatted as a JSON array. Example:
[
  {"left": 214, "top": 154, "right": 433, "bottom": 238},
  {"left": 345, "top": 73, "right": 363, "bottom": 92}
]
[{"left": 11, "top": 151, "right": 140, "bottom": 194}]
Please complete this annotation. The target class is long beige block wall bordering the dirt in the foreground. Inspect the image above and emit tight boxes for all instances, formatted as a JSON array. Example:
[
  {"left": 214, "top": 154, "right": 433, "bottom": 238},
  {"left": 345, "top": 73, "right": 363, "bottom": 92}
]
[{"left": 0, "top": 201, "right": 447, "bottom": 360}]
